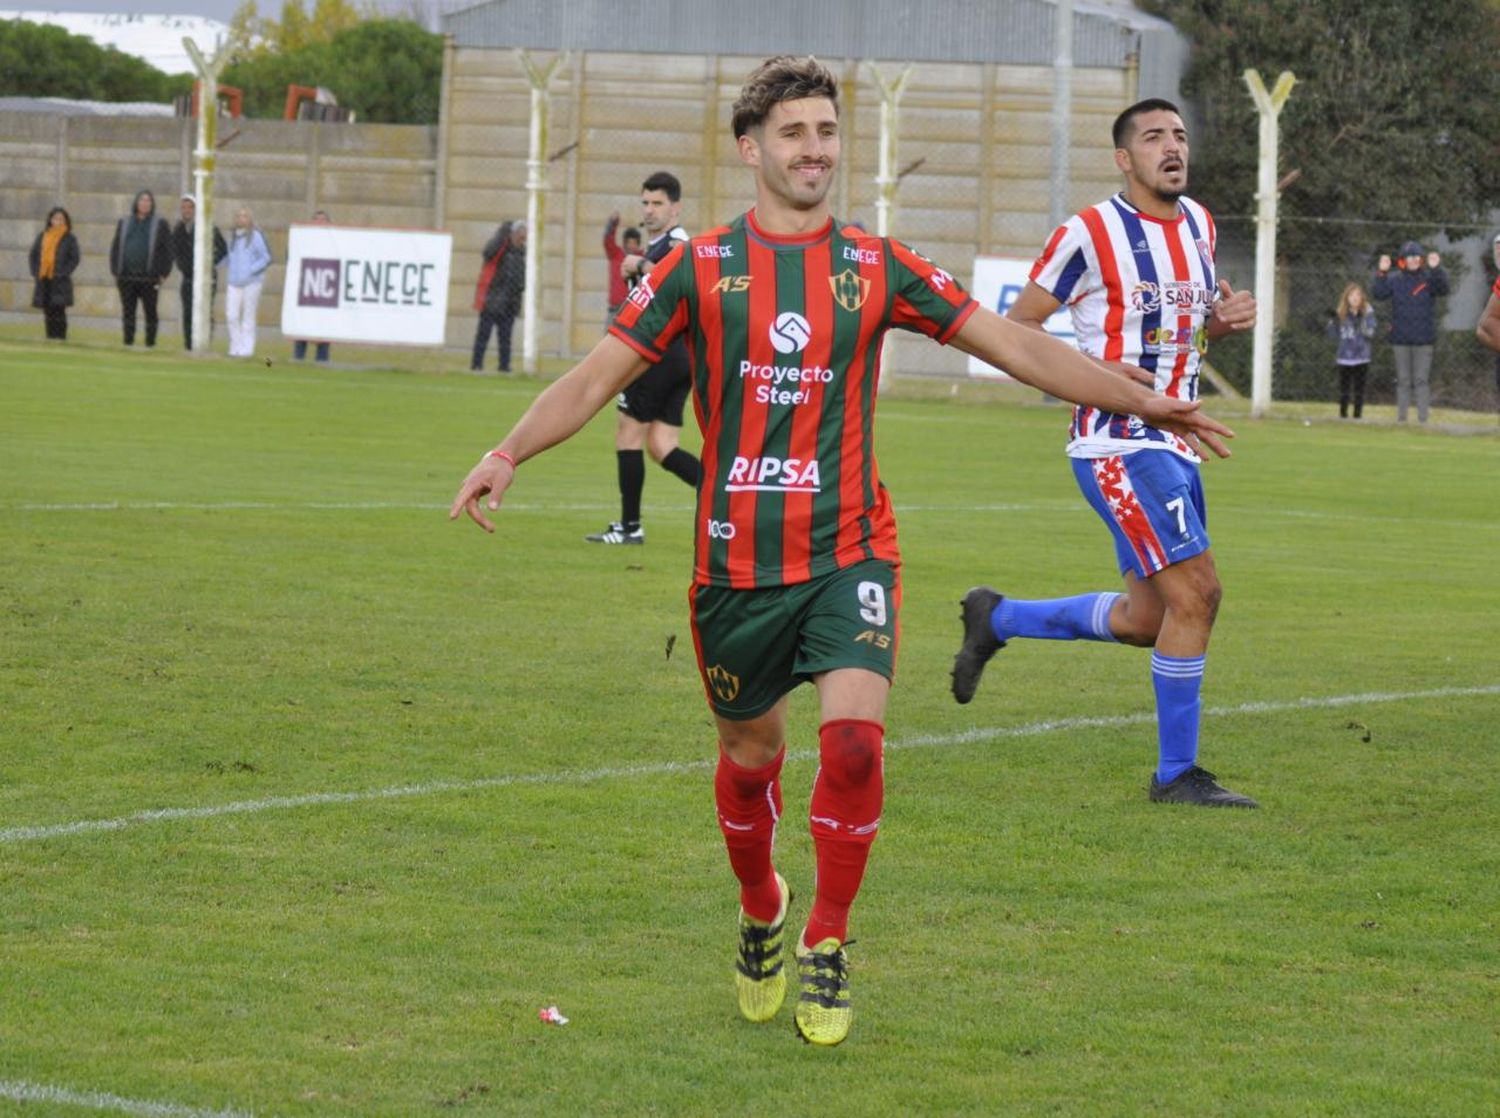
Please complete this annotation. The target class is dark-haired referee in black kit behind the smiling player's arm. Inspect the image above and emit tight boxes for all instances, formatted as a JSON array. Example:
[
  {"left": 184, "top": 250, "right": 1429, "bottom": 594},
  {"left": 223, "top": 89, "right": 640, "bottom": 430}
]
[{"left": 584, "top": 171, "right": 702, "bottom": 543}]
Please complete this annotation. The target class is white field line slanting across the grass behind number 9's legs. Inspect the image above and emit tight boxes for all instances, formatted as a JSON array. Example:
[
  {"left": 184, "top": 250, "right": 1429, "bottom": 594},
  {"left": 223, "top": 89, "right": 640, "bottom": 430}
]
[{"left": 0, "top": 683, "right": 1500, "bottom": 845}]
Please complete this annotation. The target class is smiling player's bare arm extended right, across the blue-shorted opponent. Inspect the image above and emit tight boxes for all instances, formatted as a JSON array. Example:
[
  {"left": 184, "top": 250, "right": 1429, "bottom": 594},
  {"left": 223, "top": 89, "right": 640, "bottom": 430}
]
[{"left": 953, "top": 306, "right": 1235, "bottom": 458}]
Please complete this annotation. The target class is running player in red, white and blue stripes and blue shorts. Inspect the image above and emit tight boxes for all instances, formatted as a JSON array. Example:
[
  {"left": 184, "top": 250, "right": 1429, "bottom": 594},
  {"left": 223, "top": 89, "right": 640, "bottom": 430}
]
[{"left": 953, "top": 99, "right": 1256, "bottom": 807}]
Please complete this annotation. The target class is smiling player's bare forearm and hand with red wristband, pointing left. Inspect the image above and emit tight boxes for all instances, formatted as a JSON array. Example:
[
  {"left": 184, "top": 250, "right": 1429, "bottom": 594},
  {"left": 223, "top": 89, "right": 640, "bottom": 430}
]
[{"left": 449, "top": 335, "right": 647, "bottom": 531}]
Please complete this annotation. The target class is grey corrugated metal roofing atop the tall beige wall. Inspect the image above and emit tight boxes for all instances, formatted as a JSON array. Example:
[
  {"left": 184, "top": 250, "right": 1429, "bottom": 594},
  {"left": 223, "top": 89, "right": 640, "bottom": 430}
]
[{"left": 443, "top": 0, "right": 1178, "bottom": 68}]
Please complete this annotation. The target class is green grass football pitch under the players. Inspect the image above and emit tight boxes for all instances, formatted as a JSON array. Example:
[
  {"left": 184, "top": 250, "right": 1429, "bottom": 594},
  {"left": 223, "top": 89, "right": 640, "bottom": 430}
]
[{"left": 0, "top": 336, "right": 1500, "bottom": 1116}]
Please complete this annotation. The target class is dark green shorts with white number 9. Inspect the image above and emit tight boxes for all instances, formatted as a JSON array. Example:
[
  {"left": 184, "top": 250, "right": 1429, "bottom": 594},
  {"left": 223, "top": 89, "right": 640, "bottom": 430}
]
[{"left": 687, "top": 560, "right": 902, "bottom": 722}]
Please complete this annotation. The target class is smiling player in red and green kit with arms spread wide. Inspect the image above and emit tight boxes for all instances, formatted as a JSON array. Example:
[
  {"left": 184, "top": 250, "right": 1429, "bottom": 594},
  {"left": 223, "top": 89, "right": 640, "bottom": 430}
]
[{"left": 450, "top": 56, "right": 1230, "bottom": 1044}]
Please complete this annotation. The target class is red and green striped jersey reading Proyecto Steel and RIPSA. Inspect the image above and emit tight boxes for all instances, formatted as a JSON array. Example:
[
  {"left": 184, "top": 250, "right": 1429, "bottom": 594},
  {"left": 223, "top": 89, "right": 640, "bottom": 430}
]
[{"left": 611, "top": 210, "right": 977, "bottom": 590}]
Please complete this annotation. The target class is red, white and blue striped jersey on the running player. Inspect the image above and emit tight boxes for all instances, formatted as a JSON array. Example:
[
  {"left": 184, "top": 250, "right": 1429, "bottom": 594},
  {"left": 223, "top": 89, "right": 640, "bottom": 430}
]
[{"left": 1031, "top": 194, "right": 1217, "bottom": 462}]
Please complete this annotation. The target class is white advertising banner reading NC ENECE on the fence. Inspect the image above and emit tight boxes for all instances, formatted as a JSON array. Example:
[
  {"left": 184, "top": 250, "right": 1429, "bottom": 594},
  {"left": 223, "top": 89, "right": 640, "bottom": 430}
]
[{"left": 282, "top": 225, "right": 453, "bottom": 345}]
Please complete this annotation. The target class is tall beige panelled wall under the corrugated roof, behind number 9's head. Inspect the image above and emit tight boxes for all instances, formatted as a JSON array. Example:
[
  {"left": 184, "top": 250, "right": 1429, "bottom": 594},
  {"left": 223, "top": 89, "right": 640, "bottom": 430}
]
[{"left": 443, "top": 48, "right": 1137, "bottom": 372}]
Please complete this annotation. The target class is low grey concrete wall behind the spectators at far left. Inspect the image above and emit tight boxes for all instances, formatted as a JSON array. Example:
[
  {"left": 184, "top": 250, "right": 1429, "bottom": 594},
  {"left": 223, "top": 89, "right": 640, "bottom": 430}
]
[{"left": 0, "top": 113, "right": 437, "bottom": 338}]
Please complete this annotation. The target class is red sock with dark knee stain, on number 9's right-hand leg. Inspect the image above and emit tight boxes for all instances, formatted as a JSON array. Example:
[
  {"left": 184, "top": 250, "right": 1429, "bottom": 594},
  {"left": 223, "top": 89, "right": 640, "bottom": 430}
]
[{"left": 803, "top": 719, "right": 885, "bottom": 947}]
